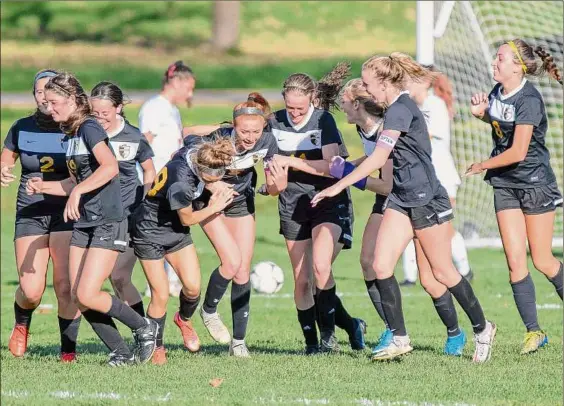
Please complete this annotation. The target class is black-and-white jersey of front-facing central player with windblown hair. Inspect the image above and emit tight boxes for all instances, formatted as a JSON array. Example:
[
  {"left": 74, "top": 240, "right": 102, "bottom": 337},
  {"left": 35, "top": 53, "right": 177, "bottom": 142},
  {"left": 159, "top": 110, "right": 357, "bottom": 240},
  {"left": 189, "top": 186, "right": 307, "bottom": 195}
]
[{"left": 269, "top": 108, "right": 349, "bottom": 221}]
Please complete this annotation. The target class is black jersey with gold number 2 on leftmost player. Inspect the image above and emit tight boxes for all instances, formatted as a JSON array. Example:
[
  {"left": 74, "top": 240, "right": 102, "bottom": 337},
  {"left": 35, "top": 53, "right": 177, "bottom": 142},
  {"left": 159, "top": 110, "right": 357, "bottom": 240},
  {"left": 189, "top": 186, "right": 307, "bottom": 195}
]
[{"left": 4, "top": 116, "right": 69, "bottom": 217}]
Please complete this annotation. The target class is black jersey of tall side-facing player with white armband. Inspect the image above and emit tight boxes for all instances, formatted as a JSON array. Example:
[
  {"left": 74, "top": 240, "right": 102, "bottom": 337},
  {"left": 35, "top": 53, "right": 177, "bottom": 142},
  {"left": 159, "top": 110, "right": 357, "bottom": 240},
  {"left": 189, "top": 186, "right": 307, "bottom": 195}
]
[{"left": 383, "top": 92, "right": 440, "bottom": 207}]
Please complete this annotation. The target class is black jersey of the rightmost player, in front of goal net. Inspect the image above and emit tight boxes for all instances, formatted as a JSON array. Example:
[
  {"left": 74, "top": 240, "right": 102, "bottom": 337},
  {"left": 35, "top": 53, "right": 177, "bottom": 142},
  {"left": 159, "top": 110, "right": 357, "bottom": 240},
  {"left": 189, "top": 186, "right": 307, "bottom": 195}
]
[{"left": 485, "top": 79, "right": 556, "bottom": 188}]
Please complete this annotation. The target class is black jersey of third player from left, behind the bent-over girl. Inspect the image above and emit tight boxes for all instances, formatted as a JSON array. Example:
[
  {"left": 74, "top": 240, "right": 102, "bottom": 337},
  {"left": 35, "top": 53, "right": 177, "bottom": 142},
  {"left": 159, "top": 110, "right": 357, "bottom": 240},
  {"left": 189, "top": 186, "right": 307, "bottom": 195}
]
[{"left": 108, "top": 120, "right": 153, "bottom": 215}]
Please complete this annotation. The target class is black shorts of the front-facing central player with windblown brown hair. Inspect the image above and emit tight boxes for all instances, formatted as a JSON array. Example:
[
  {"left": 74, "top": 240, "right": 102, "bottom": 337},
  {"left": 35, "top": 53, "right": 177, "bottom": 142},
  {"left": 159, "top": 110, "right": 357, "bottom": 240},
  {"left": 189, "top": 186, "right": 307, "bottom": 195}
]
[{"left": 280, "top": 203, "right": 353, "bottom": 249}]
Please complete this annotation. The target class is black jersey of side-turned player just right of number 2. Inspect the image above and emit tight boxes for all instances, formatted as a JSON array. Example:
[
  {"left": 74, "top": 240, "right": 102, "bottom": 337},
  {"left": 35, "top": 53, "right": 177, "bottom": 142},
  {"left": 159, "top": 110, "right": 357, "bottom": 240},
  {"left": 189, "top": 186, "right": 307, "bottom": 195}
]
[{"left": 67, "top": 118, "right": 124, "bottom": 228}]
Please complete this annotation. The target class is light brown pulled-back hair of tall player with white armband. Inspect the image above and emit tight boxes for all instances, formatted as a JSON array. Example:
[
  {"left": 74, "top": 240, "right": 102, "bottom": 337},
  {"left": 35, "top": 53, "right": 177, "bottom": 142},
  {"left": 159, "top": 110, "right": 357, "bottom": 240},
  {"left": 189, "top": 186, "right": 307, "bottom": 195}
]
[{"left": 362, "top": 52, "right": 437, "bottom": 90}]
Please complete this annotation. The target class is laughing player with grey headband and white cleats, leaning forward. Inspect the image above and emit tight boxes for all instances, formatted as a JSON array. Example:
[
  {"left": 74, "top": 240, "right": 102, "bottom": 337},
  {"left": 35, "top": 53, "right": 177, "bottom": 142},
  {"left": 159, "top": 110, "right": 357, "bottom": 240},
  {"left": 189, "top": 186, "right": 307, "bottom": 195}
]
[{"left": 189, "top": 93, "right": 287, "bottom": 357}]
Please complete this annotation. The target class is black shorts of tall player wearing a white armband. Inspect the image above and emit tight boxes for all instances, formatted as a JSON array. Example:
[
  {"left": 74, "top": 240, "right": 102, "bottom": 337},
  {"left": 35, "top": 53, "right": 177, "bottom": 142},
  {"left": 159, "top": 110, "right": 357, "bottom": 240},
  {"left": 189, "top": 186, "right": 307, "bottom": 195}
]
[{"left": 384, "top": 187, "right": 454, "bottom": 230}]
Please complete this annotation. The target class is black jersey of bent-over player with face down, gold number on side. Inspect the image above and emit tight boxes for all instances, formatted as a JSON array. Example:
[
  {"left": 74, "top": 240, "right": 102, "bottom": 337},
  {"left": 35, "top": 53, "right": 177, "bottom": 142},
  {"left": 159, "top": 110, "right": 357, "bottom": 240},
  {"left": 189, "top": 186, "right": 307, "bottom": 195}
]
[{"left": 135, "top": 147, "right": 205, "bottom": 232}]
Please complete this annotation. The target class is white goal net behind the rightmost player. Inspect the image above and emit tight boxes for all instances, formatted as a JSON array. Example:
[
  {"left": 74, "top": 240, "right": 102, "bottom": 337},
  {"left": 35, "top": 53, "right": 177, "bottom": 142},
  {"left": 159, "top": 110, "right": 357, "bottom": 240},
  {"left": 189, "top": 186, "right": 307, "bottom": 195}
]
[{"left": 434, "top": 1, "right": 564, "bottom": 246}]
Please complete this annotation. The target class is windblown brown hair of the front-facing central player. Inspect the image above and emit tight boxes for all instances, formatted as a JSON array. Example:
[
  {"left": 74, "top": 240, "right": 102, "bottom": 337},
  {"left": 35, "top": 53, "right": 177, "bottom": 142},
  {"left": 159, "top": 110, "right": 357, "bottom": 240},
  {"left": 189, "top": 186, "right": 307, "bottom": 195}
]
[{"left": 282, "top": 62, "right": 351, "bottom": 111}]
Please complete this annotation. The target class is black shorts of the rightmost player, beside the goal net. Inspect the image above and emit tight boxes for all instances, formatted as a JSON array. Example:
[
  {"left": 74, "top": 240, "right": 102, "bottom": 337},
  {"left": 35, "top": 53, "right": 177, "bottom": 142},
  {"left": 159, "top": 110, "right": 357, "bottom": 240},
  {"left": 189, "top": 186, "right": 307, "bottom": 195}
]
[{"left": 494, "top": 182, "right": 562, "bottom": 214}]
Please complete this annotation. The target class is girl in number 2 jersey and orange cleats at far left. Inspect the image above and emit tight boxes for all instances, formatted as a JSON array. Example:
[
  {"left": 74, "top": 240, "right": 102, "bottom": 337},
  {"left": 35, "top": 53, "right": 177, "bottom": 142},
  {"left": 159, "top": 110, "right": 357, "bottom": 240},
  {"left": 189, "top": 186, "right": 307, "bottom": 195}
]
[{"left": 1, "top": 70, "right": 80, "bottom": 362}]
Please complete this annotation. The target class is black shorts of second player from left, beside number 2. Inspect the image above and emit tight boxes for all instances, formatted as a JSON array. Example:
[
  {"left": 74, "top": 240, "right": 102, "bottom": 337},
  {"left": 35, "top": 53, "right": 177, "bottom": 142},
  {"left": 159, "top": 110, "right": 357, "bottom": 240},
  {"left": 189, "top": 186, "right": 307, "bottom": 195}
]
[{"left": 71, "top": 219, "right": 129, "bottom": 252}]
